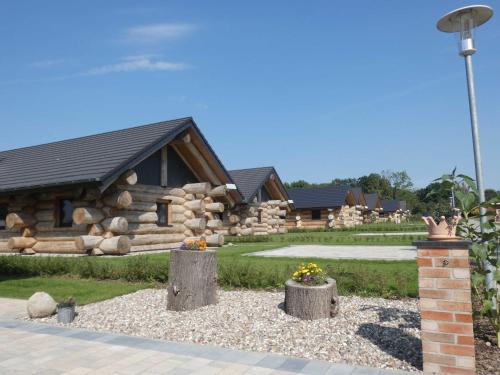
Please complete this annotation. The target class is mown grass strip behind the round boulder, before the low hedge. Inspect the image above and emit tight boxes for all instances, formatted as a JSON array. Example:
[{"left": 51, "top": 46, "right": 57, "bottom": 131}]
[{"left": 0, "top": 277, "right": 152, "bottom": 305}]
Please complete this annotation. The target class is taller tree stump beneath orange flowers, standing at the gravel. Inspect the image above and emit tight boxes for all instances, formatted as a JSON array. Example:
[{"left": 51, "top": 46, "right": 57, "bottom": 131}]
[{"left": 167, "top": 250, "right": 217, "bottom": 311}]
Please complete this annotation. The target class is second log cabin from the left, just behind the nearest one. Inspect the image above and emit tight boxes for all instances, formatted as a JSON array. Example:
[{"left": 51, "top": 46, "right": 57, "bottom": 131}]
[{"left": 219, "top": 167, "right": 293, "bottom": 236}]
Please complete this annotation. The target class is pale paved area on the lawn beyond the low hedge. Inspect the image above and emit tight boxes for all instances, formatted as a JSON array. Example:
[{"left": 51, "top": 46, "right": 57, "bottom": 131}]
[{"left": 245, "top": 245, "right": 417, "bottom": 260}]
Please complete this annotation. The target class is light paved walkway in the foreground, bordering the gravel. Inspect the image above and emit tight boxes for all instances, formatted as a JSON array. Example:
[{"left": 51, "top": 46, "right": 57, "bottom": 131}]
[{"left": 0, "top": 320, "right": 406, "bottom": 375}]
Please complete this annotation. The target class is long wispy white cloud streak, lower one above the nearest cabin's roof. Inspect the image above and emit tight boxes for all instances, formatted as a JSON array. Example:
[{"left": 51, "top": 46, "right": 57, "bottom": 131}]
[{"left": 84, "top": 55, "right": 188, "bottom": 75}]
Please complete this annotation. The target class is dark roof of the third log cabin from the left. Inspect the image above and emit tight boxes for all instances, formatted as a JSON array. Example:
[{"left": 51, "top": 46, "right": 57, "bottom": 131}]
[{"left": 287, "top": 186, "right": 351, "bottom": 209}]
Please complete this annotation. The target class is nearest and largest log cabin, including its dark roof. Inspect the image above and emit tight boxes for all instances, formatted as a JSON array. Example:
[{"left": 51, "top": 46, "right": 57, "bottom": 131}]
[{"left": 0, "top": 117, "right": 243, "bottom": 255}]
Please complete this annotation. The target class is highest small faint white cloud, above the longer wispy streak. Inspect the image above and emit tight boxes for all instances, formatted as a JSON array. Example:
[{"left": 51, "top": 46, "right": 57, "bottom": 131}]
[{"left": 125, "top": 23, "right": 196, "bottom": 42}]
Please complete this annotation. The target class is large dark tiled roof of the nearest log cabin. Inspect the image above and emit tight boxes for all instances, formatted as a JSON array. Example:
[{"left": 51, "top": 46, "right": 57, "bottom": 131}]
[{"left": 0, "top": 117, "right": 240, "bottom": 192}]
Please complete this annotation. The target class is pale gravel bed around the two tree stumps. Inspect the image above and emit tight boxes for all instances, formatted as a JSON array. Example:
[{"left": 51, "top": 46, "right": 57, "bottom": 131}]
[{"left": 39, "top": 289, "right": 422, "bottom": 371}]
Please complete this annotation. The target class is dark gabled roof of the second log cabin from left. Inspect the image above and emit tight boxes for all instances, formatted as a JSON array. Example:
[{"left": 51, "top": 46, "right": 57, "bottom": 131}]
[{"left": 229, "top": 167, "right": 286, "bottom": 203}]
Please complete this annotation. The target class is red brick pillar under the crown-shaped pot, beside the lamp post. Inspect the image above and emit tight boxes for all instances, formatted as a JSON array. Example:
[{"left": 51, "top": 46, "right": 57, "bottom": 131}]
[{"left": 414, "top": 241, "right": 476, "bottom": 374}]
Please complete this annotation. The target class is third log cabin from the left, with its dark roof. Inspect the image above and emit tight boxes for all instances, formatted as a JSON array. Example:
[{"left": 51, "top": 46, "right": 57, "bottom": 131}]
[{"left": 287, "top": 186, "right": 364, "bottom": 229}]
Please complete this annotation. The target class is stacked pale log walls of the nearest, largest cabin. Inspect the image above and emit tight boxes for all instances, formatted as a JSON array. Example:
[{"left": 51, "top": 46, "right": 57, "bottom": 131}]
[{"left": 0, "top": 170, "right": 228, "bottom": 255}]
